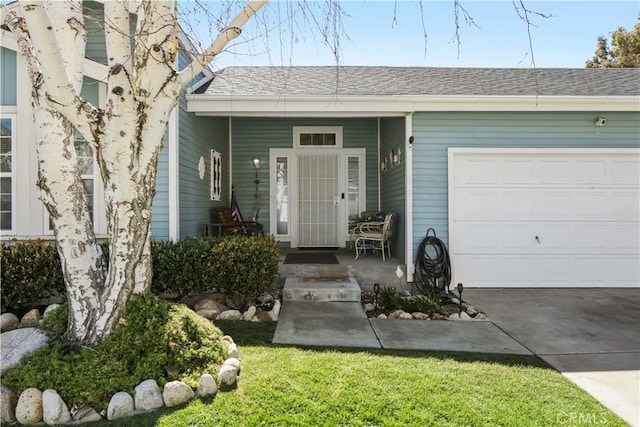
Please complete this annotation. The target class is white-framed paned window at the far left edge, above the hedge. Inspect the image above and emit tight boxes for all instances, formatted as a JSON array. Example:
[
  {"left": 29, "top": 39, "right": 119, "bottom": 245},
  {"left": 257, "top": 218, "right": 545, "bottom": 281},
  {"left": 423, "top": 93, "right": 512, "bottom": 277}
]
[{"left": 0, "top": 116, "right": 16, "bottom": 233}]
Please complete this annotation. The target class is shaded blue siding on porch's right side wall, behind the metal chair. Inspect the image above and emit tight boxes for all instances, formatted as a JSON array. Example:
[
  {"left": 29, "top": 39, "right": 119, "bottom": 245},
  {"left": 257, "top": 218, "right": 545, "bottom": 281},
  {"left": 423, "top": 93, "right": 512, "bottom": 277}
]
[{"left": 380, "top": 117, "right": 406, "bottom": 259}]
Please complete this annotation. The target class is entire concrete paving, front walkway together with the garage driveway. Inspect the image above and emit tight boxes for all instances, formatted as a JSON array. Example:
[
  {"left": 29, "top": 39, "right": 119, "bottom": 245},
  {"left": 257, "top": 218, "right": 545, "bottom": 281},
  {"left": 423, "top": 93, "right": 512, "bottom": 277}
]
[{"left": 273, "top": 289, "right": 640, "bottom": 427}]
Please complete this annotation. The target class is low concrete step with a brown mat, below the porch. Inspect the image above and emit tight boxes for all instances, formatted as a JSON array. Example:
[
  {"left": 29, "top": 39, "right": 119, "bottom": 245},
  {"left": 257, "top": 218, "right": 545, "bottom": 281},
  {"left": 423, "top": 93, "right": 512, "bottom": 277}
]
[{"left": 282, "top": 276, "right": 361, "bottom": 302}]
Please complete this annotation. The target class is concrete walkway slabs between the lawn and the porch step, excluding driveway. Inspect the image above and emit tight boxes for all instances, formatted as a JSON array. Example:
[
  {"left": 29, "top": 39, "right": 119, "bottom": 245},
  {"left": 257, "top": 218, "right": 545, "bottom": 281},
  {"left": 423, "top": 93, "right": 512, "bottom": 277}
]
[{"left": 273, "top": 300, "right": 532, "bottom": 355}]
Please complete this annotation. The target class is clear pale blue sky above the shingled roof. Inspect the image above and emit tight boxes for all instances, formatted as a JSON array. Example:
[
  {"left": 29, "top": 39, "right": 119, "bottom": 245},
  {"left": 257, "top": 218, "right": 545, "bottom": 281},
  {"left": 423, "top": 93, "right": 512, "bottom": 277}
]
[{"left": 195, "top": 0, "right": 640, "bottom": 69}]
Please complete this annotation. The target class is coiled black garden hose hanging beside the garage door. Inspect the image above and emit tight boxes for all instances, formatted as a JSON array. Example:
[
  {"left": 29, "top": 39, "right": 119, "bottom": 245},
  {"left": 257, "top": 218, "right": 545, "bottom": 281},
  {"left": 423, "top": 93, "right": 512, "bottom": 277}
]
[{"left": 415, "top": 228, "right": 451, "bottom": 294}]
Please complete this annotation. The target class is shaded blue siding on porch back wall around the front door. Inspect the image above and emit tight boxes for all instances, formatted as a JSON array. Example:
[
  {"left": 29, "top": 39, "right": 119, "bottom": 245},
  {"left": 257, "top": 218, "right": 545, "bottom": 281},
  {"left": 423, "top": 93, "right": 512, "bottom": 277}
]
[{"left": 232, "top": 118, "right": 378, "bottom": 231}]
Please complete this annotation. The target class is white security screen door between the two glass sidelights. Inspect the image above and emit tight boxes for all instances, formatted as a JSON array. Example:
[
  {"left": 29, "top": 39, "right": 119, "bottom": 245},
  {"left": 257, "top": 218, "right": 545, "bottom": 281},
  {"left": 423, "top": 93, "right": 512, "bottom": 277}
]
[{"left": 298, "top": 155, "right": 341, "bottom": 247}]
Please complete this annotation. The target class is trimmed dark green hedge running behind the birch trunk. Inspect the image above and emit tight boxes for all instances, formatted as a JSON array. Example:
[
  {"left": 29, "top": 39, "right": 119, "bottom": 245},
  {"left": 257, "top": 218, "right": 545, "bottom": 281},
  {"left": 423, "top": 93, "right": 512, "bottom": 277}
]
[{"left": 0, "top": 236, "right": 280, "bottom": 312}]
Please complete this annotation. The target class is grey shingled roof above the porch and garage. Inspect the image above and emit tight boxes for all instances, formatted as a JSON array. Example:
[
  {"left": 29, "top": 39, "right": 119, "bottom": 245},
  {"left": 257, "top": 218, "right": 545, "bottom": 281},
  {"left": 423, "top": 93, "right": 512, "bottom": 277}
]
[{"left": 196, "top": 66, "right": 640, "bottom": 97}]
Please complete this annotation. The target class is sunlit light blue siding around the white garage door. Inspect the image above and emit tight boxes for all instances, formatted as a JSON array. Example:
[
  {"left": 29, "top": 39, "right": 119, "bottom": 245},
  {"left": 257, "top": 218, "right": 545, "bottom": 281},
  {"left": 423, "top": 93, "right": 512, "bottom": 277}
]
[{"left": 413, "top": 112, "right": 640, "bottom": 254}]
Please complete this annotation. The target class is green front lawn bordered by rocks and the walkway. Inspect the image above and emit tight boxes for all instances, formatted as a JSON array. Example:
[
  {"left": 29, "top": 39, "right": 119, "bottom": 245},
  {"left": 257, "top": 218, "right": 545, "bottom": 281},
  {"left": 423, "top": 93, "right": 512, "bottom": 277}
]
[{"left": 94, "top": 321, "right": 626, "bottom": 427}]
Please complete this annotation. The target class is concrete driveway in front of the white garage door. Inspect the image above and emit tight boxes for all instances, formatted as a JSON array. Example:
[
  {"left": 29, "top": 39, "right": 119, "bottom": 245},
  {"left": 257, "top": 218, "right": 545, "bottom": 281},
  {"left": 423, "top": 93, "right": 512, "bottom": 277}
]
[{"left": 463, "top": 288, "right": 640, "bottom": 427}]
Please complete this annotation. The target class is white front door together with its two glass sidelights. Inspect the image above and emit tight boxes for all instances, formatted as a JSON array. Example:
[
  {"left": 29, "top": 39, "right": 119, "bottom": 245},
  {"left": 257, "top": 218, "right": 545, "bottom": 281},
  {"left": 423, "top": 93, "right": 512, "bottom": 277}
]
[{"left": 269, "top": 148, "right": 366, "bottom": 248}]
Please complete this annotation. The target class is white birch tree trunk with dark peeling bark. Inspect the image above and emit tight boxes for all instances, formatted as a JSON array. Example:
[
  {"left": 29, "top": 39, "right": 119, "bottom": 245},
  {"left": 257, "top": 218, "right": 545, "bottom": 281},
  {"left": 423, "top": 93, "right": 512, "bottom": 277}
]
[{"left": 2, "top": 0, "right": 266, "bottom": 346}]
